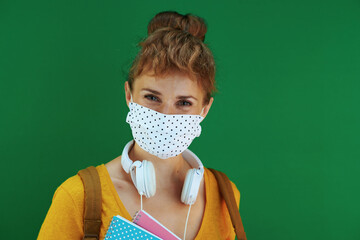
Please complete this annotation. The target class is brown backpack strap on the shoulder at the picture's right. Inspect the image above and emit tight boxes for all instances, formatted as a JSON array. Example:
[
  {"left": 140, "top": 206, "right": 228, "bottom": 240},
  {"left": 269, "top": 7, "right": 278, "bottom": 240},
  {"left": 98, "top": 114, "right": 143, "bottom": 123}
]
[{"left": 208, "top": 168, "right": 246, "bottom": 240}]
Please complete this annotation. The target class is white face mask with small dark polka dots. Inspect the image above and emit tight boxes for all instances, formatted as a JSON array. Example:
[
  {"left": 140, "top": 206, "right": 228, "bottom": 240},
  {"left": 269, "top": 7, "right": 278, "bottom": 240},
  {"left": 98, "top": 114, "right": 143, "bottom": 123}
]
[{"left": 126, "top": 94, "right": 204, "bottom": 159}]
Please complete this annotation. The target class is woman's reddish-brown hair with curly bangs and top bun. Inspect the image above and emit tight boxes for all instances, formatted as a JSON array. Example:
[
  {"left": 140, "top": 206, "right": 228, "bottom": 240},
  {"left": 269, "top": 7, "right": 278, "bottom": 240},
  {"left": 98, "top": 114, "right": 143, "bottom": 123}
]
[{"left": 128, "top": 12, "right": 216, "bottom": 104}]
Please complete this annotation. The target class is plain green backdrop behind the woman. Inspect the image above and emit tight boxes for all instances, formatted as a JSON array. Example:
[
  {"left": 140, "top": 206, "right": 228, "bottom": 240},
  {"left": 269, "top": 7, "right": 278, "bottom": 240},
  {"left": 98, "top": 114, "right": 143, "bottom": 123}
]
[{"left": 0, "top": 0, "right": 360, "bottom": 240}]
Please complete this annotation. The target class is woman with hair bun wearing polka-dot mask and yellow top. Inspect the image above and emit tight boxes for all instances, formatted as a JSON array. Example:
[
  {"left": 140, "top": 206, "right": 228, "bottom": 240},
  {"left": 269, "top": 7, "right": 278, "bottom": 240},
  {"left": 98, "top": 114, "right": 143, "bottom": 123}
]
[{"left": 38, "top": 12, "right": 240, "bottom": 239}]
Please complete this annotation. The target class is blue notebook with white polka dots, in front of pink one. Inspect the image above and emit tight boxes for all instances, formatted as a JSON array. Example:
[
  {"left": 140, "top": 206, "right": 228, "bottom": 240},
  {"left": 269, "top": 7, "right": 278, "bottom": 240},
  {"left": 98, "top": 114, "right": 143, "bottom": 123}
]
[{"left": 105, "top": 216, "right": 162, "bottom": 240}]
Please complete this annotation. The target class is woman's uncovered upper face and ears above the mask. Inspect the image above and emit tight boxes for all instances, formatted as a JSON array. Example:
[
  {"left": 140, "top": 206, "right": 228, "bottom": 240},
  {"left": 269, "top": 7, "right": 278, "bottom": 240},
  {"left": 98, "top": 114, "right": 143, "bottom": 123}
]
[{"left": 125, "top": 74, "right": 213, "bottom": 117}]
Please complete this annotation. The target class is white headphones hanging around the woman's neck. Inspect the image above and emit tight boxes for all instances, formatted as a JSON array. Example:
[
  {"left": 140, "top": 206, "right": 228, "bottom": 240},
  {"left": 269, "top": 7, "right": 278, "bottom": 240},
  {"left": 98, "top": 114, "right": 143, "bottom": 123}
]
[{"left": 121, "top": 140, "right": 204, "bottom": 205}]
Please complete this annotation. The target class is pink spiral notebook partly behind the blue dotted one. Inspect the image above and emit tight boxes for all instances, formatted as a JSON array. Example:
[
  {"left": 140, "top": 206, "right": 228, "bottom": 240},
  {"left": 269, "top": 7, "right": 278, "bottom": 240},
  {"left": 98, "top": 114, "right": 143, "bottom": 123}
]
[{"left": 133, "top": 210, "right": 181, "bottom": 240}]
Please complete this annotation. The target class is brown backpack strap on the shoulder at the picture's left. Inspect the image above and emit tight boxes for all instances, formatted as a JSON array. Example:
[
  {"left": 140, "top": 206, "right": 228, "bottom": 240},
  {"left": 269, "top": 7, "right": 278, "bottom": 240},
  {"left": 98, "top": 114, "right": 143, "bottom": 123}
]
[{"left": 78, "top": 166, "right": 102, "bottom": 240}]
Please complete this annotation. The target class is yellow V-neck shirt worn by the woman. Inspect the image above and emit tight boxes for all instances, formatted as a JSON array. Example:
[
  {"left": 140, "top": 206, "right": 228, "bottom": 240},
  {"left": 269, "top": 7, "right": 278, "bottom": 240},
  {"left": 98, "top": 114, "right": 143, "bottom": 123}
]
[{"left": 38, "top": 164, "right": 240, "bottom": 240}]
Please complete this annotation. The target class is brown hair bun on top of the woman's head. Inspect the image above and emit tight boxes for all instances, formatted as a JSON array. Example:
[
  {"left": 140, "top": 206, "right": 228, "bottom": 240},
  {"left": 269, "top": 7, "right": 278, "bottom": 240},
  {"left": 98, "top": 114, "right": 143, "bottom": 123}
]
[{"left": 148, "top": 11, "right": 207, "bottom": 41}]
